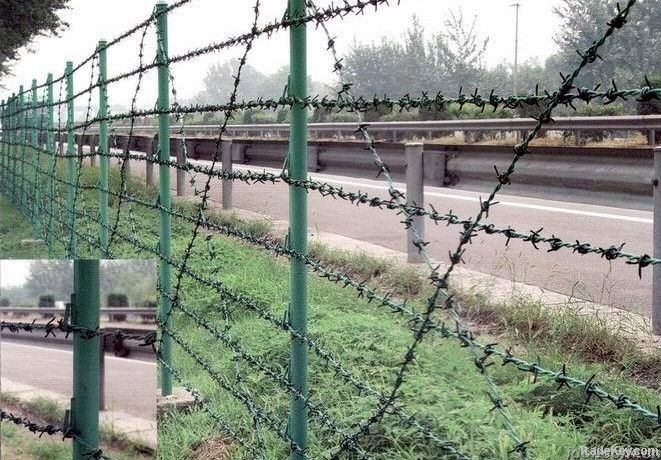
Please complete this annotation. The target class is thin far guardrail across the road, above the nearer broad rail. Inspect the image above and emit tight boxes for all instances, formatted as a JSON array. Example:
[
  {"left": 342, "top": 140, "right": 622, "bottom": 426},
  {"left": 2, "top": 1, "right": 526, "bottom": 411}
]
[{"left": 88, "top": 115, "right": 661, "bottom": 144}]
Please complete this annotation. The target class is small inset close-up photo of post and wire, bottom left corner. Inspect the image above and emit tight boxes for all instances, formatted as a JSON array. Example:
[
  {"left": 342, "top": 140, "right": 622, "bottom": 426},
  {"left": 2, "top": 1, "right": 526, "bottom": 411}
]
[{"left": 0, "top": 260, "right": 157, "bottom": 460}]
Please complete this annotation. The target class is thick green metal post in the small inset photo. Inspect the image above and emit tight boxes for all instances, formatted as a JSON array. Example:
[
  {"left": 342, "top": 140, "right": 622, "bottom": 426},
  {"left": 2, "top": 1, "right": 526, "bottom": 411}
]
[{"left": 71, "top": 260, "right": 101, "bottom": 460}]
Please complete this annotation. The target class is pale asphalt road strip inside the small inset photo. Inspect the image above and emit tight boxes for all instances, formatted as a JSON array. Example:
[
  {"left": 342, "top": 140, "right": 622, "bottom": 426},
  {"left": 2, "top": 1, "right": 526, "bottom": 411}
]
[{"left": 0, "top": 336, "right": 156, "bottom": 420}]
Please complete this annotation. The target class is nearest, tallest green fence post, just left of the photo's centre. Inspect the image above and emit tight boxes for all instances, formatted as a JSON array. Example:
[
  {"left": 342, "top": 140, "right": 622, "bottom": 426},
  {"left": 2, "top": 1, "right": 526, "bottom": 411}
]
[{"left": 289, "top": 0, "right": 308, "bottom": 460}]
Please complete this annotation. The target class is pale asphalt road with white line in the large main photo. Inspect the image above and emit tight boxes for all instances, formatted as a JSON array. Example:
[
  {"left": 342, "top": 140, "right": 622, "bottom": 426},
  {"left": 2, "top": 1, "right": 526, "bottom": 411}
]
[{"left": 122, "top": 157, "right": 652, "bottom": 315}]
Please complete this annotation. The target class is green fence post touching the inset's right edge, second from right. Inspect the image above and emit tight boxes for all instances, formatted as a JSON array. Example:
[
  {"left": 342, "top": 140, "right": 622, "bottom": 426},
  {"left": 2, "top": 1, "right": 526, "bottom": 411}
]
[{"left": 156, "top": 0, "right": 172, "bottom": 396}]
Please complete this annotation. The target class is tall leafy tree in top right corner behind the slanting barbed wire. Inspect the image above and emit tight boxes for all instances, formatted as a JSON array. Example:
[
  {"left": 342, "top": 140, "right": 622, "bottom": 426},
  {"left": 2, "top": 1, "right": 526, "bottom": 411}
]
[{"left": 547, "top": 0, "right": 661, "bottom": 87}]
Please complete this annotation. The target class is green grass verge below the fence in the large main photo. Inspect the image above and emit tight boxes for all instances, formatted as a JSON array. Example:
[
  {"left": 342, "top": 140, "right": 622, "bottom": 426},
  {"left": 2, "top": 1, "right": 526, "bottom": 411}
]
[{"left": 0, "top": 157, "right": 661, "bottom": 460}]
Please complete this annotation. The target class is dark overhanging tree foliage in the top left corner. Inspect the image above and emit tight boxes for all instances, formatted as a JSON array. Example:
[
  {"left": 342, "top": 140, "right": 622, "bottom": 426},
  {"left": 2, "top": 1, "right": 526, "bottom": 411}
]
[{"left": 0, "top": 0, "right": 69, "bottom": 77}]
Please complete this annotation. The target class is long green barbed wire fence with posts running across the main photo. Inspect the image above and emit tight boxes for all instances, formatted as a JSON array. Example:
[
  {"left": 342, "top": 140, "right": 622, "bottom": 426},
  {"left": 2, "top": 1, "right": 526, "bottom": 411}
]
[{"left": 0, "top": 0, "right": 661, "bottom": 459}]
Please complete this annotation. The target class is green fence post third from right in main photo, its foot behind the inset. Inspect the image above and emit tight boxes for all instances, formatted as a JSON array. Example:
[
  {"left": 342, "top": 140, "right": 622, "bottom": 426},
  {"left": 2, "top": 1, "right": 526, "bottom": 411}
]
[{"left": 96, "top": 40, "right": 110, "bottom": 258}]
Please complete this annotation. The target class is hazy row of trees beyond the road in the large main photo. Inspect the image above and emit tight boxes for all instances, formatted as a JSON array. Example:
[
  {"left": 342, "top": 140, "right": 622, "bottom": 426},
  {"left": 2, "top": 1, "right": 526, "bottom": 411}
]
[{"left": 192, "top": 0, "right": 661, "bottom": 123}]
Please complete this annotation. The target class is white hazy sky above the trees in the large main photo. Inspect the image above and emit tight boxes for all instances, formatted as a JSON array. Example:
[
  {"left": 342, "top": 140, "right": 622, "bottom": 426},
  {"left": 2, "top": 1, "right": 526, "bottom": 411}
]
[{"left": 0, "top": 0, "right": 559, "bottom": 107}]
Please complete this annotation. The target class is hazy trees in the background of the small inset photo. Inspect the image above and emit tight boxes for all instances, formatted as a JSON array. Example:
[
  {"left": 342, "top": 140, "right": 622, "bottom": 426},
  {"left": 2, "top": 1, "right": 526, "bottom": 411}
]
[{"left": 0, "top": 260, "right": 156, "bottom": 306}]
